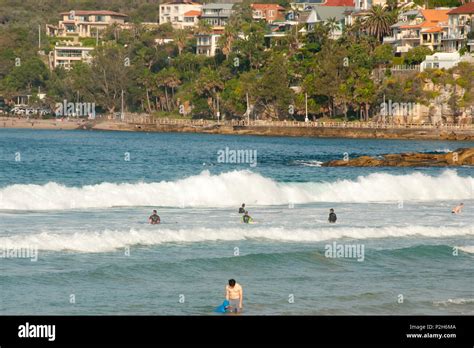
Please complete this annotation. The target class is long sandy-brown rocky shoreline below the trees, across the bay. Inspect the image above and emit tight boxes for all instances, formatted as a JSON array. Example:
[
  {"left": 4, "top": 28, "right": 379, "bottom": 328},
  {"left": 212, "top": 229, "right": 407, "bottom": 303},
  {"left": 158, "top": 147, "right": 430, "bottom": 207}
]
[{"left": 0, "top": 117, "right": 474, "bottom": 141}]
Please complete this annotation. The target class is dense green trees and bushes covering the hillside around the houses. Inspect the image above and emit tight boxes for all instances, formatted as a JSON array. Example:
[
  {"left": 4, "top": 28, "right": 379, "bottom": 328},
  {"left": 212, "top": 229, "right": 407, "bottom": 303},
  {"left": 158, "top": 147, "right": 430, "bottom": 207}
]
[{"left": 0, "top": 0, "right": 474, "bottom": 119}]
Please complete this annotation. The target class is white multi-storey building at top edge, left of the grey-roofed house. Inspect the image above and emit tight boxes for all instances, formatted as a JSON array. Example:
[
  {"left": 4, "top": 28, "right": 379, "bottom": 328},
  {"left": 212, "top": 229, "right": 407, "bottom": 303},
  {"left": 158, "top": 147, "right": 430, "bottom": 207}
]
[{"left": 159, "top": 0, "right": 202, "bottom": 29}]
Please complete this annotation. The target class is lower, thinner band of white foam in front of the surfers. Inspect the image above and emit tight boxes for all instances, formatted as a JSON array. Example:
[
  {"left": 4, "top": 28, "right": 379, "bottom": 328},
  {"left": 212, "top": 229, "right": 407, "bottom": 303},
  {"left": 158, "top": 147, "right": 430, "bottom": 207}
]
[{"left": 0, "top": 226, "right": 474, "bottom": 252}]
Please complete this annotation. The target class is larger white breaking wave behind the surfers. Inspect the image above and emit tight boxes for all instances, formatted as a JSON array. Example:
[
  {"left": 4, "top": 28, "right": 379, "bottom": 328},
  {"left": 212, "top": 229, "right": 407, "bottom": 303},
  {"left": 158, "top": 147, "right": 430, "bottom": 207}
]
[{"left": 0, "top": 170, "right": 474, "bottom": 210}]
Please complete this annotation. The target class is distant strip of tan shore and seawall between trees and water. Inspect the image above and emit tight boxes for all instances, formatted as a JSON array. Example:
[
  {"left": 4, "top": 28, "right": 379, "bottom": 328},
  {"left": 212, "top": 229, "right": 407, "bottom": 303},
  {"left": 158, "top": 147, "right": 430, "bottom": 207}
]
[{"left": 0, "top": 117, "right": 474, "bottom": 141}]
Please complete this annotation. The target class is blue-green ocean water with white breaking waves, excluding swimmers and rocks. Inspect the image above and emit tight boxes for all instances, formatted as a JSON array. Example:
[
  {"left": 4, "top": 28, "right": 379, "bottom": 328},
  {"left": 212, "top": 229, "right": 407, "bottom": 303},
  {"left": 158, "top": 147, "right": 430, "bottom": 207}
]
[{"left": 0, "top": 129, "right": 474, "bottom": 315}]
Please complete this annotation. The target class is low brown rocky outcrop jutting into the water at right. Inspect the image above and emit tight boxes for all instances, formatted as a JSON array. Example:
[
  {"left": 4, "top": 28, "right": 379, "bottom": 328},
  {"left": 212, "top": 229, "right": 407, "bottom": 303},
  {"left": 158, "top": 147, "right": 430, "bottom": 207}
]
[{"left": 322, "top": 148, "right": 474, "bottom": 167}]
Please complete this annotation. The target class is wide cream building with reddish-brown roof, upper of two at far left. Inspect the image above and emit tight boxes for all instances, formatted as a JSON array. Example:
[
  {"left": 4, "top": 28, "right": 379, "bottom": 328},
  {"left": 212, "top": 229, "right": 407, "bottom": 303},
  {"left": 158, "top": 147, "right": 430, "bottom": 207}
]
[{"left": 46, "top": 10, "right": 128, "bottom": 37}]
